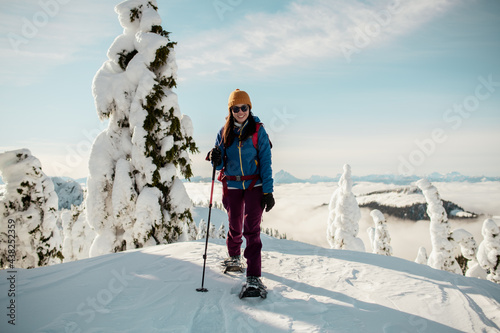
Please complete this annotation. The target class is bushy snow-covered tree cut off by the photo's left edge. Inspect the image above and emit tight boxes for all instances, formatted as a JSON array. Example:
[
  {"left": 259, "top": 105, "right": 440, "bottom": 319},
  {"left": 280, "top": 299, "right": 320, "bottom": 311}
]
[{"left": 0, "top": 149, "right": 63, "bottom": 268}]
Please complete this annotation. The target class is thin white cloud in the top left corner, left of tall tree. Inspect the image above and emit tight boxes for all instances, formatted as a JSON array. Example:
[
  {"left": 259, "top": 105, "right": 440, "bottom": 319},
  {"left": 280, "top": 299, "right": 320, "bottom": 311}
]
[{"left": 0, "top": 0, "right": 121, "bottom": 86}]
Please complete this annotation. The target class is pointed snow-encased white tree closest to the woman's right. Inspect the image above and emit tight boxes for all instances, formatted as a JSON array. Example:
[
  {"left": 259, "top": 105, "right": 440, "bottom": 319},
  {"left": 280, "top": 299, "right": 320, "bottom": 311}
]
[{"left": 327, "top": 164, "right": 365, "bottom": 251}]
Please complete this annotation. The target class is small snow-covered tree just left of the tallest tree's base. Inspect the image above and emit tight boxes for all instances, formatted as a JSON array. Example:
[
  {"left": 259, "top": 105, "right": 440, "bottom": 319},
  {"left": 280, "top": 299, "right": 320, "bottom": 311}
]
[{"left": 60, "top": 204, "right": 96, "bottom": 262}]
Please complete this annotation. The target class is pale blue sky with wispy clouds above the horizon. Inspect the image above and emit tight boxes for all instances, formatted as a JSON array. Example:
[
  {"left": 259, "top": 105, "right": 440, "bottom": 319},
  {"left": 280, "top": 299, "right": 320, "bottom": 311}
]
[{"left": 0, "top": 0, "right": 500, "bottom": 178}]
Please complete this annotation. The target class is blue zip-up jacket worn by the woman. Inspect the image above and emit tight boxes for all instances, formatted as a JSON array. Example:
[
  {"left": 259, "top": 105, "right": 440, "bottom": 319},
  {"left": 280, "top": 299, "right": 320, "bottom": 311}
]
[{"left": 215, "top": 116, "right": 273, "bottom": 193}]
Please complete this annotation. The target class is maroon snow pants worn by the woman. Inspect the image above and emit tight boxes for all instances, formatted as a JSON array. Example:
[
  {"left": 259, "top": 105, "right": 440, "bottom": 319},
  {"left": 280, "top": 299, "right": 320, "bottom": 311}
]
[{"left": 222, "top": 186, "right": 263, "bottom": 276}]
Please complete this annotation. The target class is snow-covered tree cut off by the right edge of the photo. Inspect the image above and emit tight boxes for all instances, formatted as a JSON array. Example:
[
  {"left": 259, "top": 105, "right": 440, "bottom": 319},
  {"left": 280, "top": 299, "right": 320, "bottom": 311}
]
[{"left": 477, "top": 219, "right": 500, "bottom": 283}]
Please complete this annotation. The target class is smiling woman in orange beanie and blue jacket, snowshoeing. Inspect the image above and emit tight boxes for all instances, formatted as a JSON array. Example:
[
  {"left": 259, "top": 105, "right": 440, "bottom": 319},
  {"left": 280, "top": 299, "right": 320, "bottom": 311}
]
[{"left": 209, "top": 89, "right": 274, "bottom": 289}]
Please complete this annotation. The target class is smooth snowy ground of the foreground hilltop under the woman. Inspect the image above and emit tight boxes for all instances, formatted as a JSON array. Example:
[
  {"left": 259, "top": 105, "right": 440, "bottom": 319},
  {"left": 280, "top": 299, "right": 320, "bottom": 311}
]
[{"left": 0, "top": 235, "right": 500, "bottom": 333}]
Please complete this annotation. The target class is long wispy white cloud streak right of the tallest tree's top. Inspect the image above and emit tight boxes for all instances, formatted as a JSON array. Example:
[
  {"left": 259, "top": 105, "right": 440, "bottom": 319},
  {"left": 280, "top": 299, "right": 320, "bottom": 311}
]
[{"left": 178, "top": 0, "right": 456, "bottom": 73}]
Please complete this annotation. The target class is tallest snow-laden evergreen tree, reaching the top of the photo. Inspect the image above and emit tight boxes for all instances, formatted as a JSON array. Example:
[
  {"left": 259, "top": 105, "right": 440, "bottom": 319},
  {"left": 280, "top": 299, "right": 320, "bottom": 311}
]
[{"left": 86, "top": 0, "right": 197, "bottom": 256}]
